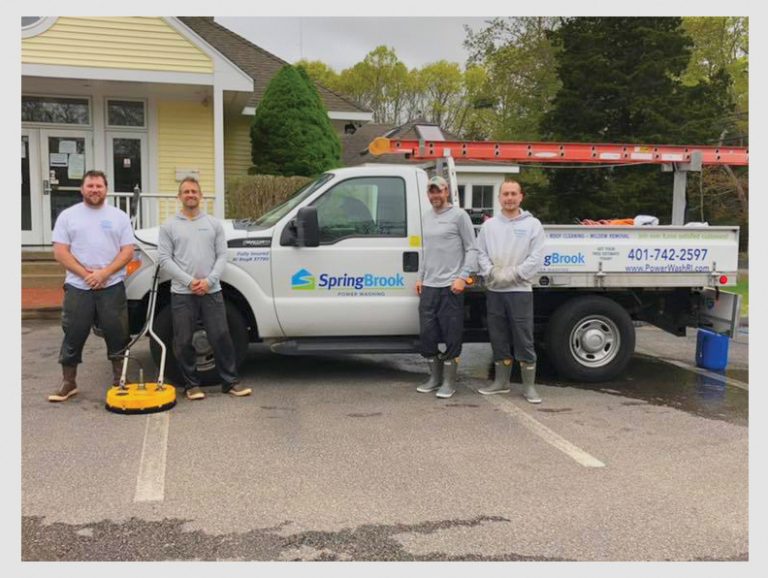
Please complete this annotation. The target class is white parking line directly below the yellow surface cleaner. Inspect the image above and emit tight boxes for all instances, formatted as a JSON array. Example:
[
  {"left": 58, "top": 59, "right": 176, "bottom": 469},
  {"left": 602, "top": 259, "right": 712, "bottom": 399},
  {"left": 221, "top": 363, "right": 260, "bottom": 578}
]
[{"left": 133, "top": 411, "right": 170, "bottom": 502}]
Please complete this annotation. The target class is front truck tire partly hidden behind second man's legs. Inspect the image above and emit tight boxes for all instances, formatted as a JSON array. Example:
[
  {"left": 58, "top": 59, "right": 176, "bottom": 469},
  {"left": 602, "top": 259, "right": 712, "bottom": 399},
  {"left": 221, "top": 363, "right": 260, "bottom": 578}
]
[{"left": 150, "top": 301, "right": 248, "bottom": 386}]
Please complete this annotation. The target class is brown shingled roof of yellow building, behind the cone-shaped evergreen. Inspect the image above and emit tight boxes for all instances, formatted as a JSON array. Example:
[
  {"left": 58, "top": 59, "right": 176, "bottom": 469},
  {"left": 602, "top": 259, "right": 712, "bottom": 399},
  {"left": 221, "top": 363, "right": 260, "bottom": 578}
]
[{"left": 179, "top": 16, "right": 371, "bottom": 113}]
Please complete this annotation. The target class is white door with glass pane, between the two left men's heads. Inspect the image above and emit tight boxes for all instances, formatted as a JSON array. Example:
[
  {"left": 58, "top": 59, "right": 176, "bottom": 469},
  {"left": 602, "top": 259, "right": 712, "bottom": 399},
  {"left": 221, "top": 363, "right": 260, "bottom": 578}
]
[{"left": 107, "top": 131, "right": 148, "bottom": 225}]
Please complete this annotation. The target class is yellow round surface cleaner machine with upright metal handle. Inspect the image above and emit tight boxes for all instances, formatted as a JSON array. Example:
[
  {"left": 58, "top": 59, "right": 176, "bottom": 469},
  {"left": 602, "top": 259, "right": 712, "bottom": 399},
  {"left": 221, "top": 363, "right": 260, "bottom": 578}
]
[{"left": 106, "top": 264, "right": 176, "bottom": 414}]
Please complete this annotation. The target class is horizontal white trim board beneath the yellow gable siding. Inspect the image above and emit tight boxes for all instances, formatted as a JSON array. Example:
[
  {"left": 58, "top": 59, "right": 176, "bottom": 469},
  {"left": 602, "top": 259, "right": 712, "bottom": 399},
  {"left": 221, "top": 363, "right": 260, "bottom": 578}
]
[{"left": 21, "top": 64, "right": 214, "bottom": 86}]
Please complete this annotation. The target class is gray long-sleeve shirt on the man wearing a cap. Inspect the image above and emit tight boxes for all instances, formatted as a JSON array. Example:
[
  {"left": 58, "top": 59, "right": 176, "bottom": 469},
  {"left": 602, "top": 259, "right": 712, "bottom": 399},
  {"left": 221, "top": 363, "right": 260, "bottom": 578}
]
[{"left": 419, "top": 207, "right": 477, "bottom": 287}]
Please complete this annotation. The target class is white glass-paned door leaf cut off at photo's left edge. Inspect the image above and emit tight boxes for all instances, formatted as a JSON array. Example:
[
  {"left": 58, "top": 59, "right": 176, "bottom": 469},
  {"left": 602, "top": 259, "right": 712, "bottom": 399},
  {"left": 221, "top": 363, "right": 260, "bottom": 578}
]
[{"left": 21, "top": 128, "right": 43, "bottom": 245}]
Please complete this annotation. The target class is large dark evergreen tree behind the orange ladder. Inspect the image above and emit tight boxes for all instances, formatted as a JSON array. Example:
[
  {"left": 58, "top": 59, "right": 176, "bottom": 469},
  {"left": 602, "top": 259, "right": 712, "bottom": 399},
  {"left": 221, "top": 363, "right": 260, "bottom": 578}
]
[{"left": 541, "top": 17, "right": 733, "bottom": 223}]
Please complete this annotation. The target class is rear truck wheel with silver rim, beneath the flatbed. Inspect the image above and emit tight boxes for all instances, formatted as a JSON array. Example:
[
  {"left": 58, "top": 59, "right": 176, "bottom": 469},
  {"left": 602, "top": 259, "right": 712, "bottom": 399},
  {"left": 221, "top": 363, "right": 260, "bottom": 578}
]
[{"left": 546, "top": 296, "right": 635, "bottom": 382}]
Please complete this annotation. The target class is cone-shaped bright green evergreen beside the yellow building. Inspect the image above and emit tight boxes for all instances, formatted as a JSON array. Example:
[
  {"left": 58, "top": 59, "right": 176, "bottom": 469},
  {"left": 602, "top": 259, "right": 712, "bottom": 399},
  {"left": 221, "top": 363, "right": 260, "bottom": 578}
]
[{"left": 251, "top": 65, "right": 341, "bottom": 177}]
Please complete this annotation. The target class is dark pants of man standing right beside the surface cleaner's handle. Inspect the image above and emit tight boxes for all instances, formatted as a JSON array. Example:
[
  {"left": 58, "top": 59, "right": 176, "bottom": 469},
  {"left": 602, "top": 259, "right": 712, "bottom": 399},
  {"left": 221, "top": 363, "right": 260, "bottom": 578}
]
[{"left": 171, "top": 291, "right": 239, "bottom": 391}]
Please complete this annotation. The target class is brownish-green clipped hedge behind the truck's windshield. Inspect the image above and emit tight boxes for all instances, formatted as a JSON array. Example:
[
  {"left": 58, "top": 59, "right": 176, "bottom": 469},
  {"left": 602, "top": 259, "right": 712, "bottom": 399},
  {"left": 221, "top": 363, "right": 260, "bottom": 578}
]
[{"left": 226, "top": 175, "right": 312, "bottom": 219}]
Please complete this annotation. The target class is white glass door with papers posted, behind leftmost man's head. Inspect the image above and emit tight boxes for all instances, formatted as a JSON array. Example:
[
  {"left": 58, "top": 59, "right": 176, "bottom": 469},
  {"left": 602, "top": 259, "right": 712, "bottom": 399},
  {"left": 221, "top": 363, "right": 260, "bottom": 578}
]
[{"left": 40, "top": 129, "right": 93, "bottom": 244}]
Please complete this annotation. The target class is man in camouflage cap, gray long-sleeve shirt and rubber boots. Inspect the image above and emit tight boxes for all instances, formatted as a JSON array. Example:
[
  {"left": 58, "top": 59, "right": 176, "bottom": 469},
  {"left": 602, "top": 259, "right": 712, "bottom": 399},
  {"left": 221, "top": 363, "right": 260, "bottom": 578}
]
[{"left": 416, "top": 176, "right": 476, "bottom": 398}]
